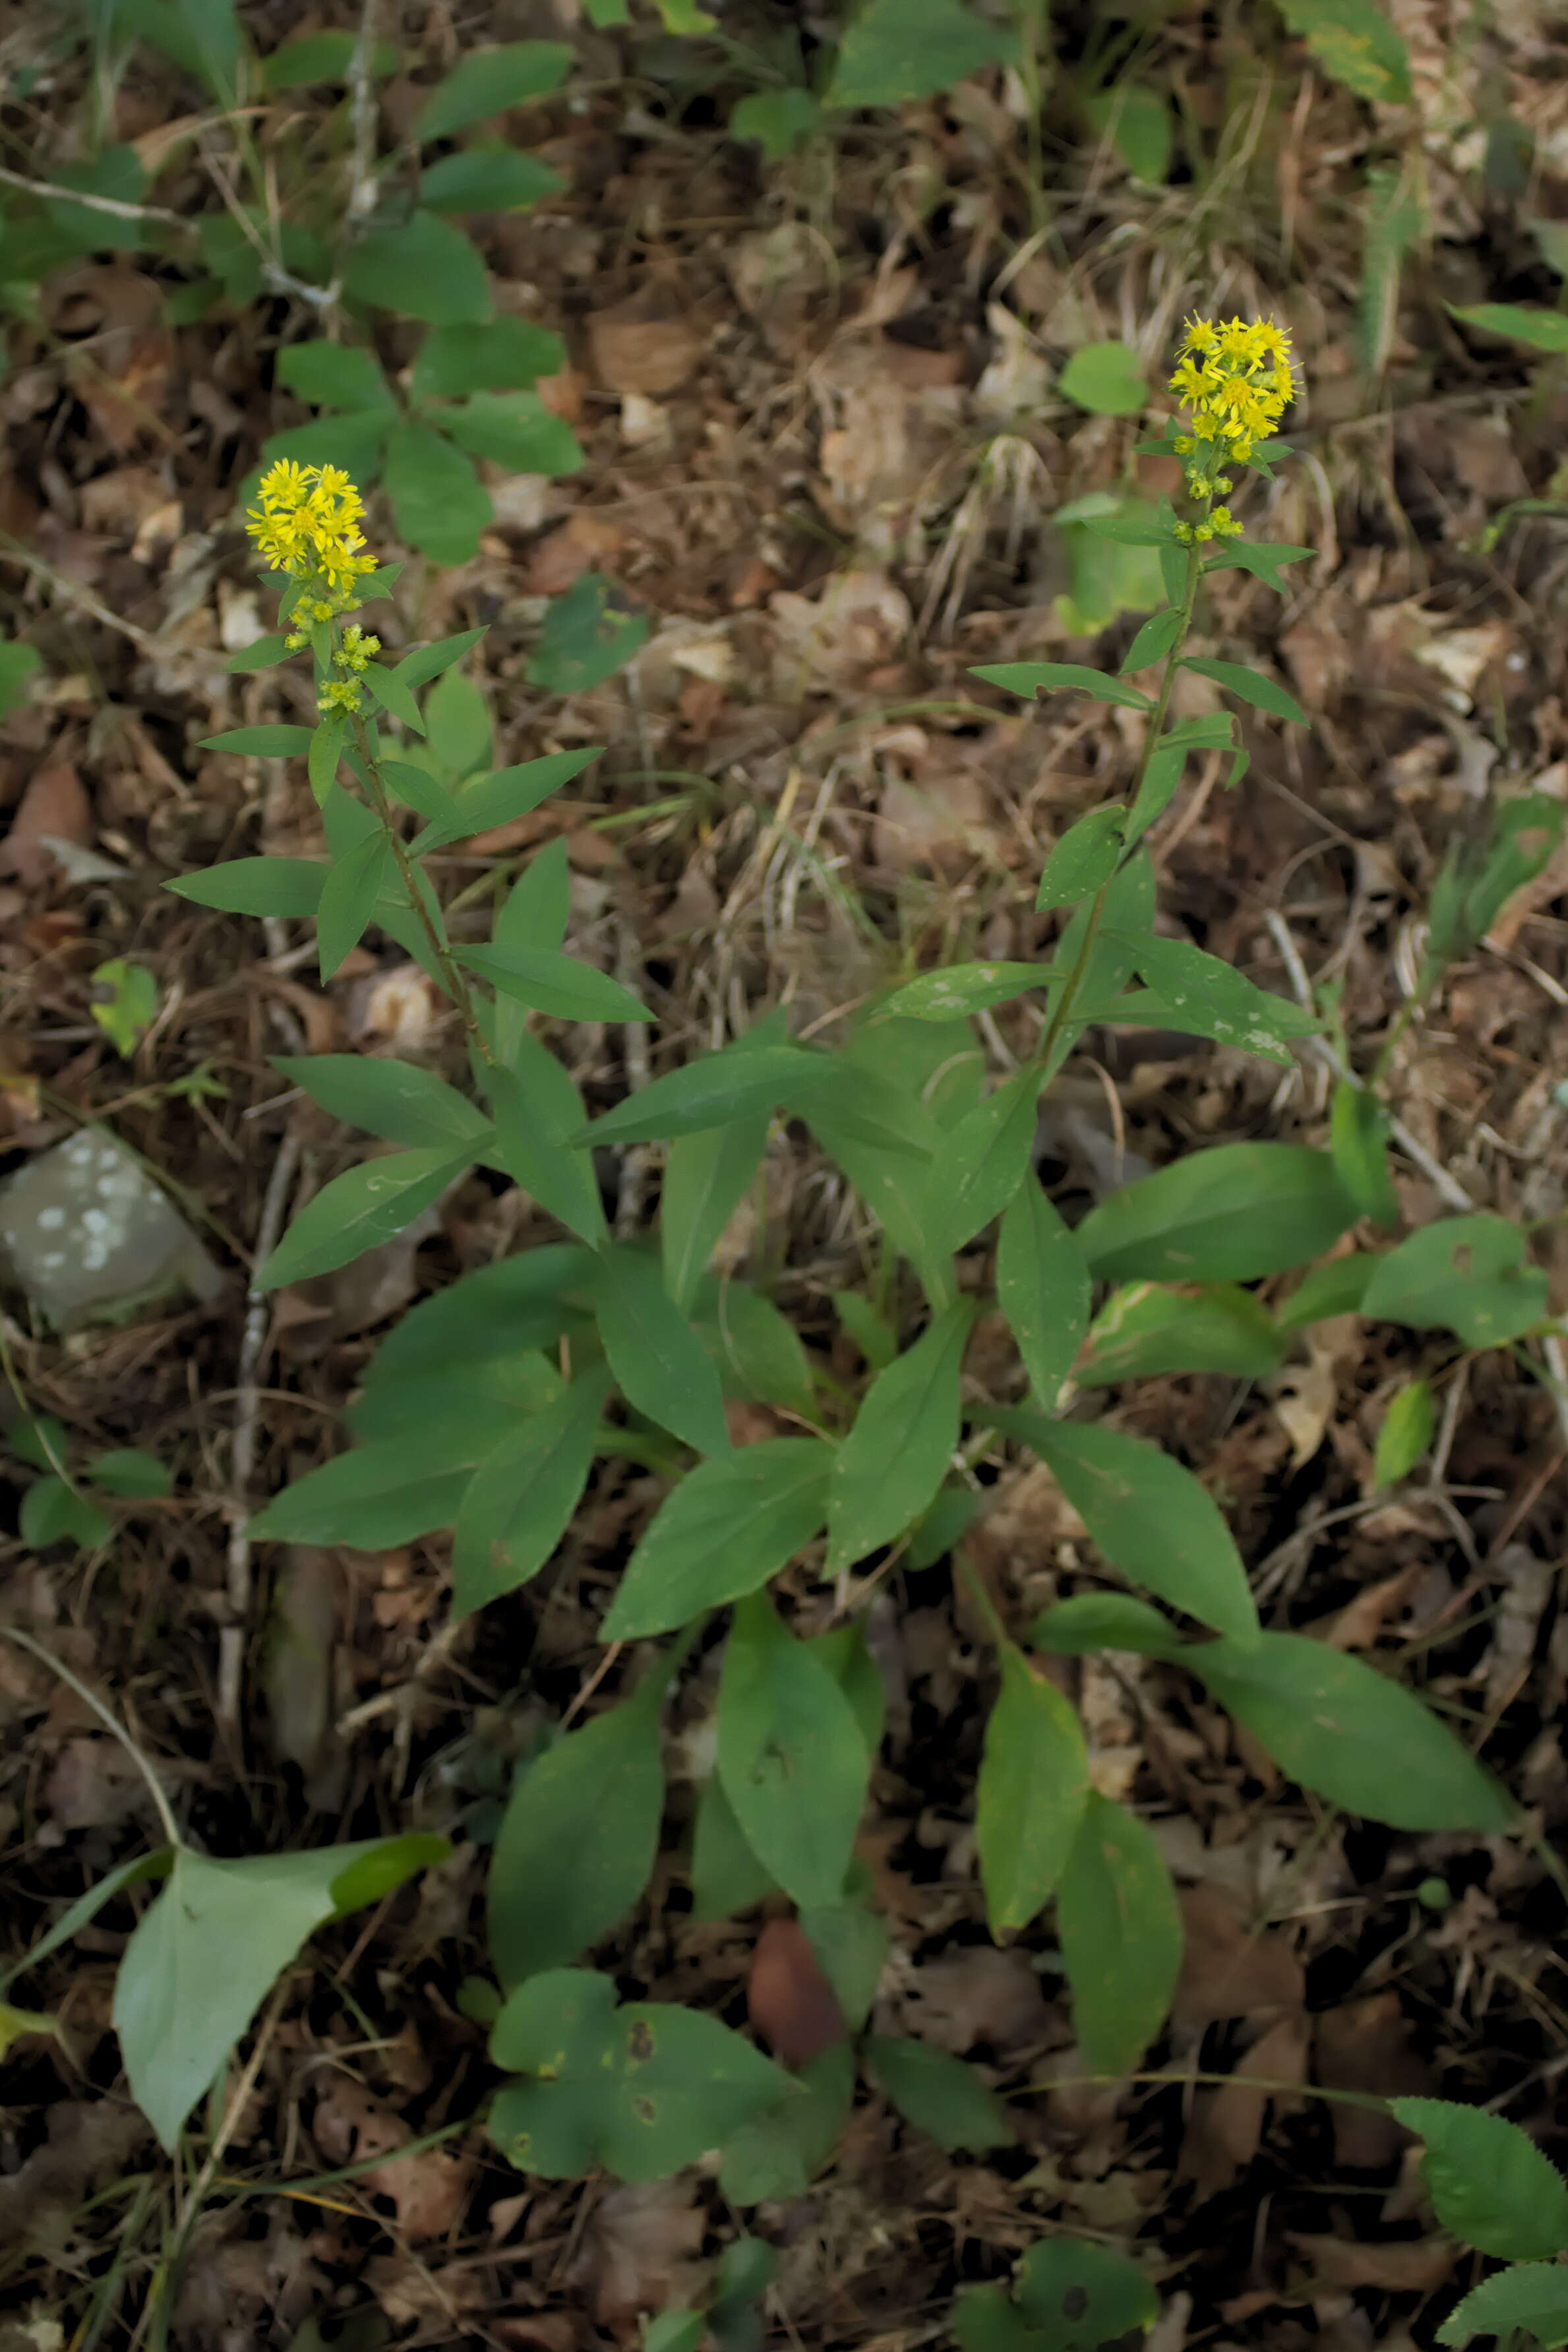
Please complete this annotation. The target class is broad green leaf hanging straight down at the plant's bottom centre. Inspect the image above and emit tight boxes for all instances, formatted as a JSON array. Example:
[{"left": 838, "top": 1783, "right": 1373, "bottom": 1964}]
[{"left": 719, "top": 1599, "right": 870, "bottom": 1905}]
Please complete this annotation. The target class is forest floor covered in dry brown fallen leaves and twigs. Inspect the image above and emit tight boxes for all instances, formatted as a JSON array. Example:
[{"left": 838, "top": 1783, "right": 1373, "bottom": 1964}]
[{"left": 0, "top": 0, "right": 1568, "bottom": 2352}]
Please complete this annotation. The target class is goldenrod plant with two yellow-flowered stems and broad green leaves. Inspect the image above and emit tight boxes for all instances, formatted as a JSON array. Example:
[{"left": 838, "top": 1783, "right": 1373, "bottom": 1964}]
[{"left": 15, "top": 320, "right": 1556, "bottom": 2204}]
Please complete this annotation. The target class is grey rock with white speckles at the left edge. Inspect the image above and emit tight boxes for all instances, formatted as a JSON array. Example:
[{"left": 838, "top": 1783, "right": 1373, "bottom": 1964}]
[{"left": 0, "top": 1127, "right": 224, "bottom": 1331}]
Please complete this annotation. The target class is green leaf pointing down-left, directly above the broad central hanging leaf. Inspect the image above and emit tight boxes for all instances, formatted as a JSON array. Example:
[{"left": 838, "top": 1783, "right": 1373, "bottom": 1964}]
[{"left": 599, "top": 1437, "right": 832, "bottom": 1642}]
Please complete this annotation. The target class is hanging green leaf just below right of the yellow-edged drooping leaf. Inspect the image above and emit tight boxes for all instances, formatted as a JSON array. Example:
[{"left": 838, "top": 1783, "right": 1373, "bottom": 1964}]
[{"left": 1056, "top": 1790, "right": 1182, "bottom": 2074}]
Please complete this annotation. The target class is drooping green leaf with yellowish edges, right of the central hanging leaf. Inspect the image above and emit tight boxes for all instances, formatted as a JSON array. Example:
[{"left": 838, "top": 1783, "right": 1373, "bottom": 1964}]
[{"left": 976, "top": 1642, "right": 1089, "bottom": 1941}]
